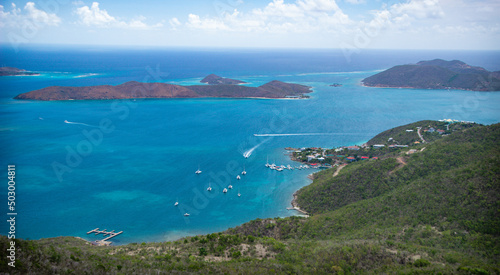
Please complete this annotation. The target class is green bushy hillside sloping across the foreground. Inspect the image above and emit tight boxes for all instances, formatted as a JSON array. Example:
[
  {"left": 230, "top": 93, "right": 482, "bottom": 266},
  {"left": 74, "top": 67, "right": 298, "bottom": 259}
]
[{"left": 0, "top": 121, "right": 500, "bottom": 274}]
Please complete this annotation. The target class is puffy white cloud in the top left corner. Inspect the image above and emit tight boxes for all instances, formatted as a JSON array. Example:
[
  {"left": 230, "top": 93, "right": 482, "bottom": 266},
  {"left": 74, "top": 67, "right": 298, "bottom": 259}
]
[{"left": 0, "top": 2, "right": 61, "bottom": 28}]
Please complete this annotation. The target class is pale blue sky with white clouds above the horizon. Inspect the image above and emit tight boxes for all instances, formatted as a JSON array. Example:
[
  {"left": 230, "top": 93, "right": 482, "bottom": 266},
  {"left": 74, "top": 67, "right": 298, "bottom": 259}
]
[{"left": 0, "top": 0, "right": 500, "bottom": 50}]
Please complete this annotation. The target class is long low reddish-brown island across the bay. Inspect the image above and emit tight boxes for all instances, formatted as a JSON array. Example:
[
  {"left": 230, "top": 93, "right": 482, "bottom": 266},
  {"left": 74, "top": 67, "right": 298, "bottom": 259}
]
[{"left": 15, "top": 75, "right": 312, "bottom": 101}]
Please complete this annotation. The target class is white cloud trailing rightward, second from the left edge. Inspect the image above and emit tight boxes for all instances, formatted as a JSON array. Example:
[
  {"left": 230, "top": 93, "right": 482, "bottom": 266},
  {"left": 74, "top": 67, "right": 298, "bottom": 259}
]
[{"left": 75, "top": 2, "right": 163, "bottom": 30}]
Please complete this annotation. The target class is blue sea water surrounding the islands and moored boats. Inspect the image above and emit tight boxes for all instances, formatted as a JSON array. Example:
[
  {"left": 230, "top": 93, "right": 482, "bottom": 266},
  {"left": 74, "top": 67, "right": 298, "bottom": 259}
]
[{"left": 0, "top": 46, "right": 500, "bottom": 244}]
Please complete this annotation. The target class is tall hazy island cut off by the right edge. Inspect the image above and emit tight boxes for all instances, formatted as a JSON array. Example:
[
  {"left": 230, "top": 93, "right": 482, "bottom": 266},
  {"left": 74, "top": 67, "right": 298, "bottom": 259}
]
[{"left": 362, "top": 59, "right": 500, "bottom": 91}]
